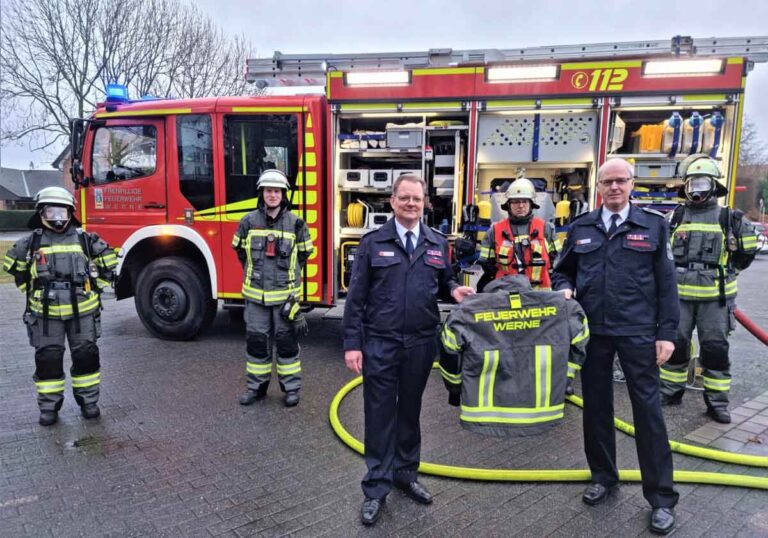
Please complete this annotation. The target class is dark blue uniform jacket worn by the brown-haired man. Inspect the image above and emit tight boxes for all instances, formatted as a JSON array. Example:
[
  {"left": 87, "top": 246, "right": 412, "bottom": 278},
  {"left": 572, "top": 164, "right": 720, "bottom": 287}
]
[{"left": 343, "top": 219, "right": 459, "bottom": 351}]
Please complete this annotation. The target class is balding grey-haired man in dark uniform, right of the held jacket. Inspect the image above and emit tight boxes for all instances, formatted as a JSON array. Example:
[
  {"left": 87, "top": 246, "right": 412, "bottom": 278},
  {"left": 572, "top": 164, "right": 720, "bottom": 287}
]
[{"left": 553, "top": 159, "right": 680, "bottom": 534}]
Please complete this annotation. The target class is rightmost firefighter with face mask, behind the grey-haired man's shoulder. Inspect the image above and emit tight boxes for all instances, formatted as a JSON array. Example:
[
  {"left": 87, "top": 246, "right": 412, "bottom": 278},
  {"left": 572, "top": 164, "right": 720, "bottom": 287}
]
[{"left": 661, "top": 154, "right": 757, "bottom": 424}]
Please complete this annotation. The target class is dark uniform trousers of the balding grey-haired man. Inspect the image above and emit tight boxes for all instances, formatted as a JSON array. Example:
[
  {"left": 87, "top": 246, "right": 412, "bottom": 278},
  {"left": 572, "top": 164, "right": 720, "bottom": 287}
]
[{"left": 581, "top": 334, "right": 678, "bottom": 508}]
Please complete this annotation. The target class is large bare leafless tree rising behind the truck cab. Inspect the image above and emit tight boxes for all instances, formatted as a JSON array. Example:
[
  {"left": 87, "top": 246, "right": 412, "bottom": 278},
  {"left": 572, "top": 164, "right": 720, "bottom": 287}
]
[{"left": 0, "top": 0, "right": 252, "bottom": 153}]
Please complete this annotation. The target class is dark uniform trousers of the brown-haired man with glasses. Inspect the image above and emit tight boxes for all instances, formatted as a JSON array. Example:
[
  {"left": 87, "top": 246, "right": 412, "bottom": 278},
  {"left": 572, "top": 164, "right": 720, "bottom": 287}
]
[{"left": 362, "top": 338, "right": 437, "bottom": 499}]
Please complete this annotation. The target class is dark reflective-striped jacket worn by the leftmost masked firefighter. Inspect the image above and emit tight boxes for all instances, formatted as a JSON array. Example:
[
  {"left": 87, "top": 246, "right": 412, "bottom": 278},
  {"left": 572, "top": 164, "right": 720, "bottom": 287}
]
[{"left": 3, "top": 226, "right": 117, "bottom": 320}]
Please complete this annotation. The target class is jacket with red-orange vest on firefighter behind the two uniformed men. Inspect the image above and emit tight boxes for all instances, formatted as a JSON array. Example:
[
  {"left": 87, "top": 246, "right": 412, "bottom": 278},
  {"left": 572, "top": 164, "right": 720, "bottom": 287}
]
[{"left": 478, "top": 217, "right": 557, "bottom": 289}]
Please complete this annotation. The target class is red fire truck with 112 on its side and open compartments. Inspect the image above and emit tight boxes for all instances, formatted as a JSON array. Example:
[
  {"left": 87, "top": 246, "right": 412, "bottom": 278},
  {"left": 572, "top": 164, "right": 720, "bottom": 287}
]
[{"left": 72, "top": 37, "right": 768, "bottom": 339}]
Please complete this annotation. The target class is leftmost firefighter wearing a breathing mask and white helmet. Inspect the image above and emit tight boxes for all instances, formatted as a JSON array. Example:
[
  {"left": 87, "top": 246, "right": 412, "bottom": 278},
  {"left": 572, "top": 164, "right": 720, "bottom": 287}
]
[{"left": 3, "top": 187, "right": 117, "bottom": 426}]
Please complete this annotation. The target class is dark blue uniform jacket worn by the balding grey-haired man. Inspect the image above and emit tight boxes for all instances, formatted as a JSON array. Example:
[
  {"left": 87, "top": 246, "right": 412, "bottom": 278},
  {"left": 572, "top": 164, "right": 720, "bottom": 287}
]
[{"left": 552, "top": 206, "right": 680, "bottom": 342}]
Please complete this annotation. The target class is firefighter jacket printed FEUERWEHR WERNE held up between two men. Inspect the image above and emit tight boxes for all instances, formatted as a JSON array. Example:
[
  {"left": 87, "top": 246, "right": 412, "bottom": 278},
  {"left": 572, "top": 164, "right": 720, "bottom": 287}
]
[{"left": 440, "top": 275, "right": 589, "bottom": 436}]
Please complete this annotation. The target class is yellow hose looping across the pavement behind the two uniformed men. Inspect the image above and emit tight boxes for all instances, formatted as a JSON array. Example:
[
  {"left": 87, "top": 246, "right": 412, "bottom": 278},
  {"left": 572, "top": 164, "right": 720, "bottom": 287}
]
[{"left": 329, "top": 363, "right": 768, "bottom": 489}]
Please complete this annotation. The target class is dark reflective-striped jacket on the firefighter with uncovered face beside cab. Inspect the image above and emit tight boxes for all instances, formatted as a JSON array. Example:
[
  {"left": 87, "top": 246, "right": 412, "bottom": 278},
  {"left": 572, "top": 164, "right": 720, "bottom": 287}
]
[{"left": 232, "top": 206, "right": 313, "bottom": 306}]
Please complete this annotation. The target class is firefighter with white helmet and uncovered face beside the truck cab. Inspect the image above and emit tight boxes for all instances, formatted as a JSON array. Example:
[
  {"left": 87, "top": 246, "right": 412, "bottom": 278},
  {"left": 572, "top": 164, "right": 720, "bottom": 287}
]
[{"left": 232, "top": 170, "right": 313, "bottom": 407}]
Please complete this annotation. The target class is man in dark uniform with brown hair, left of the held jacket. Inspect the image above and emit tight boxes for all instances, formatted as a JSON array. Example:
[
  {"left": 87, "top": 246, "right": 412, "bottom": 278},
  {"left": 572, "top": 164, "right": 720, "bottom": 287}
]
[{"left": 343, "top": 174, "right": 474, "bottom": 525}]
